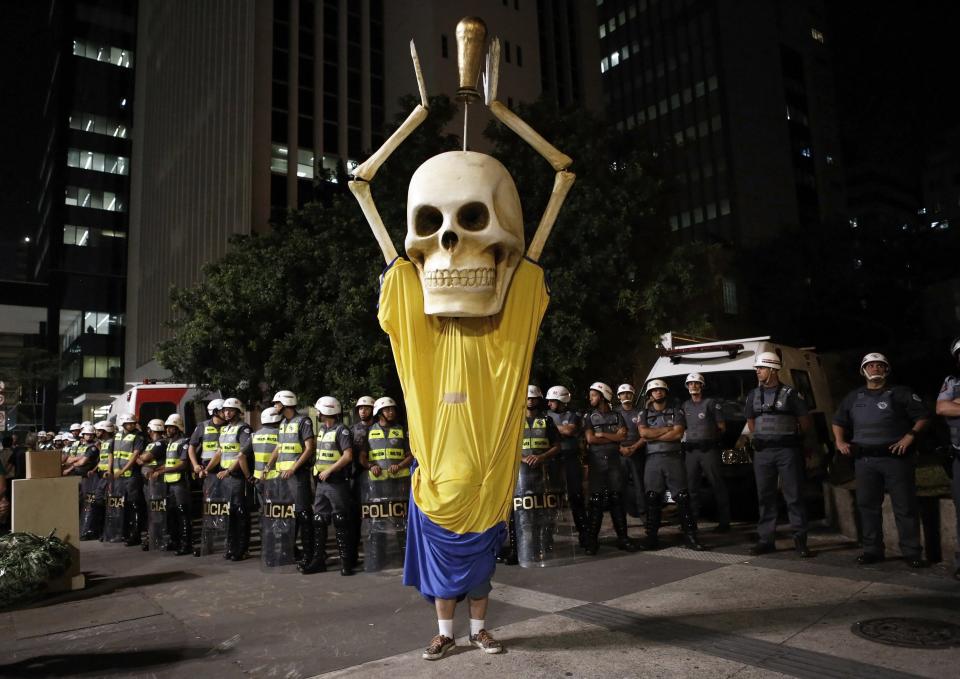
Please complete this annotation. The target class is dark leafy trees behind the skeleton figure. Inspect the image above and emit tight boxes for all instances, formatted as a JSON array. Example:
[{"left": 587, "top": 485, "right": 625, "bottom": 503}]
[{"left": 157, "top": 97, "right": 713, "bottom": 402}]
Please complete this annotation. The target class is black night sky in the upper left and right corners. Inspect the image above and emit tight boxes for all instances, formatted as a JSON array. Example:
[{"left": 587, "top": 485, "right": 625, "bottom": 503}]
[{"left": 0, "top": 0, "right": 960, "bottom": 255}]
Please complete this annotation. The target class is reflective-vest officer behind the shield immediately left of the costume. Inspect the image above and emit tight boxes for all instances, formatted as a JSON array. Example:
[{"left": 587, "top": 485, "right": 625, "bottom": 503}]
[{"left": 354, "top": 396, "right": 413, "bottom": 572}]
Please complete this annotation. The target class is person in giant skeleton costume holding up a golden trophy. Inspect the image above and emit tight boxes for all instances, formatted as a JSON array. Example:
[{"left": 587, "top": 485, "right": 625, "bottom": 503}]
[{"left": 350, "top": 18, "right": 574, "bottom": 660}]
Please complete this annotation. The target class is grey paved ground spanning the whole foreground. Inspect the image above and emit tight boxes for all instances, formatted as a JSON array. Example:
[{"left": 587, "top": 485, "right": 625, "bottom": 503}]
[{"left": 0, "top": 526, "right": 960, "bottom": 679}]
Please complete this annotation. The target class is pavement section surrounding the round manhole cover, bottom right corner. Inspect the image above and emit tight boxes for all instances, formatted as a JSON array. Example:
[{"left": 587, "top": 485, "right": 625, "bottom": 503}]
[{"left": 787, "top": 584, "right": 960, "bottom": 677}]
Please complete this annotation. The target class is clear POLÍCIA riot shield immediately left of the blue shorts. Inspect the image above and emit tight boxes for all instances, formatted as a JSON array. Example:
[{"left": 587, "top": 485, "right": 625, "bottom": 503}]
[{"left": 360, "top": 474, "right": 410, "bottom": 573}]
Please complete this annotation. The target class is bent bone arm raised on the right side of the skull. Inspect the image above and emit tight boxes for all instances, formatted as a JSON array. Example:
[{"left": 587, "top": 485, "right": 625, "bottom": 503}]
[{"left": 484, "top": 38, "right": 577, "bottom": 261}]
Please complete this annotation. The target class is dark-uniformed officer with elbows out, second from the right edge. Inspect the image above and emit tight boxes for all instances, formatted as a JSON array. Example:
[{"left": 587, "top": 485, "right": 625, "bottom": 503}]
[{"left": 833, "top": 352, "right": 930, "bottom": 568}]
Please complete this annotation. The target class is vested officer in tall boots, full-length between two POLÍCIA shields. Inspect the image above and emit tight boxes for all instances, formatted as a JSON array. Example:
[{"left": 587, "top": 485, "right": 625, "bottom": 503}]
[{"left": 302, "top": 396, "right": 357, "bottom": 575}]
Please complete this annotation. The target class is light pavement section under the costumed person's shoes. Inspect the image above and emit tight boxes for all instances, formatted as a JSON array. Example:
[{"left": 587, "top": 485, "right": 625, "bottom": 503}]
[{"left": 321, "top": 615, "right": 756, "bottom": 679}]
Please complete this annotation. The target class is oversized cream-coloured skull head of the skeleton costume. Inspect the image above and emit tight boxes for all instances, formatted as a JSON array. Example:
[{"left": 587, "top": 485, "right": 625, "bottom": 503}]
[{"left": 404, "top": 151, "right": 524, "bottom": 316}]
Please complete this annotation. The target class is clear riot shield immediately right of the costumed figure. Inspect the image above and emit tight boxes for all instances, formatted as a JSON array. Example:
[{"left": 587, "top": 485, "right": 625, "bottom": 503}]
[{"left": 513, "top": 460, "right": 578, "bottom": 568}]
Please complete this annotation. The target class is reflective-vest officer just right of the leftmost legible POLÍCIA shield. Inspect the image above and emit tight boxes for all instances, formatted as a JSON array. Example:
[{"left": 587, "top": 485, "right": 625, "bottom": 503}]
[{"left": 207, "top": 398, "right": 253, "bottom": 561}]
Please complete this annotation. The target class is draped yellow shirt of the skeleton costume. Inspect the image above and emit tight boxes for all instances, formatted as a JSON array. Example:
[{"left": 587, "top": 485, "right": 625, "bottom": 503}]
[{"left": 379, "top": 259, "right": 549, "bottom": 534}]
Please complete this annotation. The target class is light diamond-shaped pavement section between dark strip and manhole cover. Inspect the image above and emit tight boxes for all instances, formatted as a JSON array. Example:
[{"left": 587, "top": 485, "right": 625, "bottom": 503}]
[{"left": 606, "top": 565, "right": 866, "bottom": 643}]
